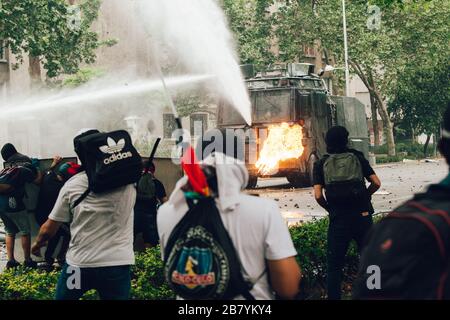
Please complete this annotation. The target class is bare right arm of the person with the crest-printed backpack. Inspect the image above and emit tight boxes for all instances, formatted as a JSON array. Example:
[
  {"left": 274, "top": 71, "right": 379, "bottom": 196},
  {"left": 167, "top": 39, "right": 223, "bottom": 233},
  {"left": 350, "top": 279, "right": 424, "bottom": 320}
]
[{"left": 267, "top": 257, "right": 302, "bottom": 299}]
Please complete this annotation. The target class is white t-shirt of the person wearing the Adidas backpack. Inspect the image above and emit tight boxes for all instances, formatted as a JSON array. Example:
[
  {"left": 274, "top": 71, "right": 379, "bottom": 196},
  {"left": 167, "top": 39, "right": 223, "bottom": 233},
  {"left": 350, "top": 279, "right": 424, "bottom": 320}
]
[{"left": 49, "top": 172, "right": 136, "bottom": 268}]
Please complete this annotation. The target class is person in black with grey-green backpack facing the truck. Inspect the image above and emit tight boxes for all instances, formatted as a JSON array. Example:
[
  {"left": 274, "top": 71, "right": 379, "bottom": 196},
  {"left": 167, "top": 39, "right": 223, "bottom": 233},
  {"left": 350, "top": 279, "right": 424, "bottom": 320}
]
[{"left": 313, "top": 126, "right": 381, "bottom": 300}]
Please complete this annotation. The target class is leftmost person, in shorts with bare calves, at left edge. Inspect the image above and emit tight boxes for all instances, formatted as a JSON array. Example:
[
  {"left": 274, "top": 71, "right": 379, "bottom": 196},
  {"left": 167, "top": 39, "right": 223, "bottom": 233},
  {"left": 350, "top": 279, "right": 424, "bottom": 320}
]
[{"left": 0, "top": 143, "right": 40, "bottom": 268}]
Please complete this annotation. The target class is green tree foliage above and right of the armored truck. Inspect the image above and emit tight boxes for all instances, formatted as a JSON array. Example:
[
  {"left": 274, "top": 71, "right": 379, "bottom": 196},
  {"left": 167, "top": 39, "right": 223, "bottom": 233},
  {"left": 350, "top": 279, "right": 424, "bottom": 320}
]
[{"left": 224, "top": 0, "right": 450, "bottom": 155}]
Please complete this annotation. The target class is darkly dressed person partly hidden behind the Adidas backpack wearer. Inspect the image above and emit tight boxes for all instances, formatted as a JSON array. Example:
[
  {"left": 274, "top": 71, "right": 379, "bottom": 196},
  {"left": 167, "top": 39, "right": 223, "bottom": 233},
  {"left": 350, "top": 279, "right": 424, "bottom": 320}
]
[{"left": 35, "top": 156, "right": 80, "bottom": 270}]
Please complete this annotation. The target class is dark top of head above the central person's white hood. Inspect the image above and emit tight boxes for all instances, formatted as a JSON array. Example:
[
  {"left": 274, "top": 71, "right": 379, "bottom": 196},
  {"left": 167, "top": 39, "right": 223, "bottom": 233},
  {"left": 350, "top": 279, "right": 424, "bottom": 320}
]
[{"left": 196, "top": 129, "right": 245, "bottom": 161}]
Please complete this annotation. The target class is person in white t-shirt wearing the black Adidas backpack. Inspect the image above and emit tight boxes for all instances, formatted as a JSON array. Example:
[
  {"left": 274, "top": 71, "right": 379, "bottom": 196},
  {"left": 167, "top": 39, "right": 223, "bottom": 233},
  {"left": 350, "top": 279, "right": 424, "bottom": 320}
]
[{"left": 32, "top": 130, "right": 142, "bottom": 300}]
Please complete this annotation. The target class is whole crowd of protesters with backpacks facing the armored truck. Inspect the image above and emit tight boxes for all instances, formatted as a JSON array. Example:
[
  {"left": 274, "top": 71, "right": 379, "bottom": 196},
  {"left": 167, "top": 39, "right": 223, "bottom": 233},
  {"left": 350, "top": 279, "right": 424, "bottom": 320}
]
[{"left": 0, "top": 105, "right": 450, "bottom": 300}]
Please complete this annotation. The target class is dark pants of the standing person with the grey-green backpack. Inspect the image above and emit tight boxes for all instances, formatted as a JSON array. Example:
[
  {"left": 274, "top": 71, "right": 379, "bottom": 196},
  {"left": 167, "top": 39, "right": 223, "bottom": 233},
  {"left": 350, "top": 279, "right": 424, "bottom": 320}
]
[{"left": 327, "top": 214, "right": 372, "bottom": 300}]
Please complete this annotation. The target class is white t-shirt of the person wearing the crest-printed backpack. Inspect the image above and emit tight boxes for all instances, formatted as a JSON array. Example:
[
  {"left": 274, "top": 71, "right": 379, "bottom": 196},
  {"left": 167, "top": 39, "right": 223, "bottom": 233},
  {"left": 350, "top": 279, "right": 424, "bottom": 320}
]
[{"left": 157, "top": 193, "right": 297, "bottom": 300}]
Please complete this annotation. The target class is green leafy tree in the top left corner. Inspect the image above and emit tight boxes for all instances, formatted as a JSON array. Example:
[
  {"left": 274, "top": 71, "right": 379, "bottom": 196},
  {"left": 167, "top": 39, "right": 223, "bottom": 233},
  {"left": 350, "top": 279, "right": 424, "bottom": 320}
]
[{"left": 0, "top": 0, "right": 114, "bottom": 82}]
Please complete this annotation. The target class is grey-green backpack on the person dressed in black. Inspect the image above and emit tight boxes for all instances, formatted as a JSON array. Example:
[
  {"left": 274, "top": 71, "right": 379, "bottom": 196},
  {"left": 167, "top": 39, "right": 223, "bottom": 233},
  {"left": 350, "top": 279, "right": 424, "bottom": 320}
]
[{"left": 323, "top": 152, "right": 369, "bottom": 210}]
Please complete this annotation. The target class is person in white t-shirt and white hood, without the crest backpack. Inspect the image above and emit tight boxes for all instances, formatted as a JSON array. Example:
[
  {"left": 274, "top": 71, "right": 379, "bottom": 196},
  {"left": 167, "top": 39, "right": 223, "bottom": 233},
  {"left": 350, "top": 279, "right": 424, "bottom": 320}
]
[{"left": 157, "top": 130, "right": 301, "bottom": 299}]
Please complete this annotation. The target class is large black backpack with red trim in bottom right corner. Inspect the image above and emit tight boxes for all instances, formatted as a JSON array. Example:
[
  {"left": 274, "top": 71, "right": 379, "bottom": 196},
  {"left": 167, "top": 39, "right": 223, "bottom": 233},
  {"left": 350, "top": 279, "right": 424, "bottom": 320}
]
[{"left": 353, "top": 186, "right": 450, "bottom": 300}]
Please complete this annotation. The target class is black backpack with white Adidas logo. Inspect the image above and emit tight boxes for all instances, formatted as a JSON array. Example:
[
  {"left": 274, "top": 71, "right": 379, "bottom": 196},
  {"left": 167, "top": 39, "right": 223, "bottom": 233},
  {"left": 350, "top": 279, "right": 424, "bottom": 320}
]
[{"left": 74, "top": 130, "right": 142, "bottom": 207}]
